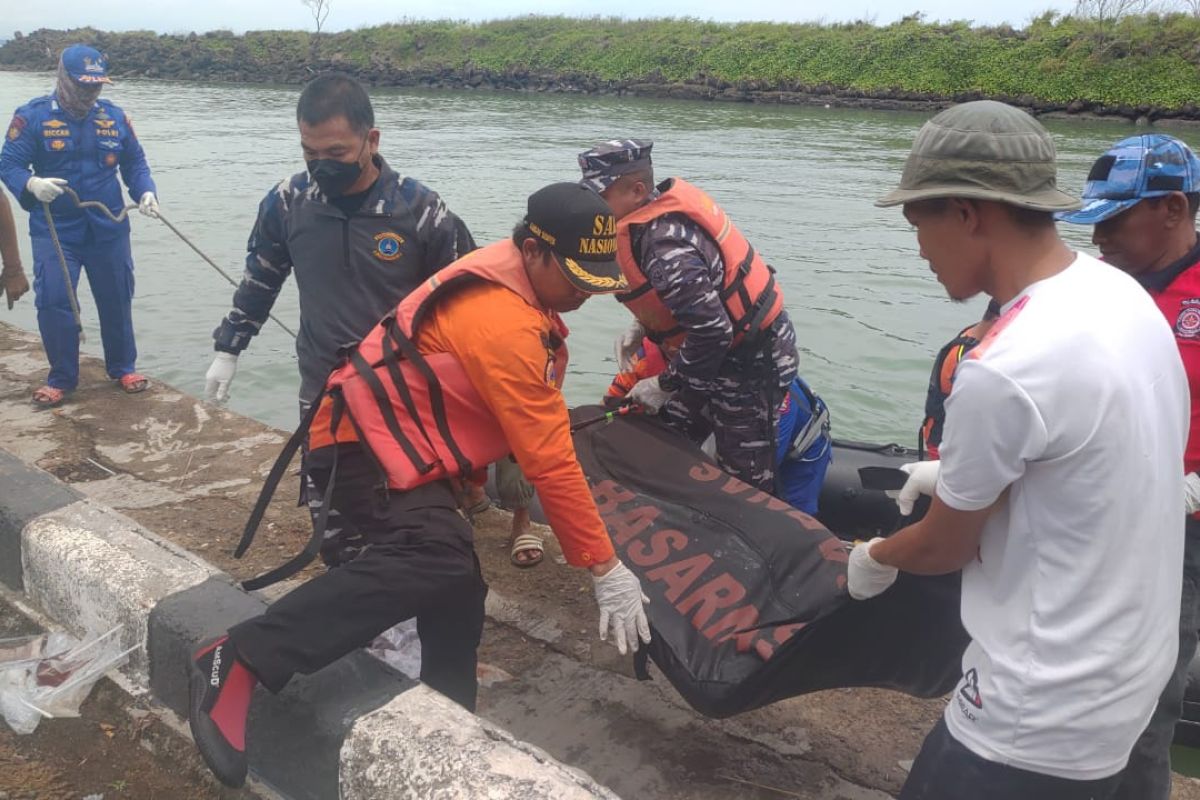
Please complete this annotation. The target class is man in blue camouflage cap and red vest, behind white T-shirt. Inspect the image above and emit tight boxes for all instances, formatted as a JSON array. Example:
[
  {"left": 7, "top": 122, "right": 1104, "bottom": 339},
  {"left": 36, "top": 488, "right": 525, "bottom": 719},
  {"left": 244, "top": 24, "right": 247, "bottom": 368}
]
[{"left": 1057, "top": 133, "right": 1200, "bottom": 800}]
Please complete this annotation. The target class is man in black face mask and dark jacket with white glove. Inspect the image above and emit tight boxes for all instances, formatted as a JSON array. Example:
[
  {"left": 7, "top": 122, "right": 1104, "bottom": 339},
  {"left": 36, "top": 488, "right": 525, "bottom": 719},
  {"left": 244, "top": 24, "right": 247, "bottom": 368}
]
[{"left": 205, "top": 73, "right": 475, "bottom": 561}]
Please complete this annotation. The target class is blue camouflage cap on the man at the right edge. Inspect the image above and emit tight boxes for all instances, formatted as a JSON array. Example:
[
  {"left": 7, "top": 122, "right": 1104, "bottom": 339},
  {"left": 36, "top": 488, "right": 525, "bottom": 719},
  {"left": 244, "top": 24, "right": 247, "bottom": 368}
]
[{"left": 1055, "top": 133, "right": 1200, "bottom": 225}]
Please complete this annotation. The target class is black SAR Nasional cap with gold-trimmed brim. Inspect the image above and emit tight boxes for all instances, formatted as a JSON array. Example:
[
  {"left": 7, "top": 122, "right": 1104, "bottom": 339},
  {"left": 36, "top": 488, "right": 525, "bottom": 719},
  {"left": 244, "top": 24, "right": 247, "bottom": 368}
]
[{"left": 524, "top": 184, "right": 629, "bottom": 294}]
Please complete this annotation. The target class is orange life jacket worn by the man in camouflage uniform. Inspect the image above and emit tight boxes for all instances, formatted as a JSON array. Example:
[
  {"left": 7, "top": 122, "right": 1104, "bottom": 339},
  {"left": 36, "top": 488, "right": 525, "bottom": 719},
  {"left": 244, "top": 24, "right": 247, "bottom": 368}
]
[{"left": 617, "top": 178, "right": 784, "bottom": 348}]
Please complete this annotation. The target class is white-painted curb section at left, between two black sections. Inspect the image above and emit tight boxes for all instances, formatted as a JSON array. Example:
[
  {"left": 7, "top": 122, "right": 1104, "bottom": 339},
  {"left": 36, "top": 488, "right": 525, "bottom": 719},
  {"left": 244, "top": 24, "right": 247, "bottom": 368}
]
[{"left": 20, "top": 500, "right": 216, "bottom": 688}]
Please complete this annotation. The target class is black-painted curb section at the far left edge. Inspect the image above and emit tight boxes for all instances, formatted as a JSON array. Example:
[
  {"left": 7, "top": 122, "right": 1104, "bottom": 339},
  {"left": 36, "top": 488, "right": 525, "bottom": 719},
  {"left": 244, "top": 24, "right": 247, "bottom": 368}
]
[{"left": 0, "top": 450, "right": 80, "bottom": 591}]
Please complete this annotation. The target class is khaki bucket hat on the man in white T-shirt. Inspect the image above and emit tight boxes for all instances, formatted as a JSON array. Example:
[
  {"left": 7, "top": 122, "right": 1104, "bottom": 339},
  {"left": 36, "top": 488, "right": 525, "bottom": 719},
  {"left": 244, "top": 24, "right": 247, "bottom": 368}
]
[{"left": 875, "top": 100, "right": 1080, "bottom": 211}]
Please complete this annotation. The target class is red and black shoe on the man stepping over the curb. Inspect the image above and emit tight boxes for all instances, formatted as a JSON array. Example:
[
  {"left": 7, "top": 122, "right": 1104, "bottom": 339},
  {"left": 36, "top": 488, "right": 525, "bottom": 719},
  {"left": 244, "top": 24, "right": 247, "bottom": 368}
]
[{"left": 187, "top": 636, "right": 258, "bottom": 788}]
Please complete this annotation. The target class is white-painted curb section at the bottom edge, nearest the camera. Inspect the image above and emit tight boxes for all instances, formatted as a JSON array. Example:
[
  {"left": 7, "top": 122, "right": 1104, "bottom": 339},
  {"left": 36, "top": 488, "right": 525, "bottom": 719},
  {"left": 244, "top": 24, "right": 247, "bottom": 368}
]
[{"left": 341, "top": 686, "right": 617, "bottom": 800}]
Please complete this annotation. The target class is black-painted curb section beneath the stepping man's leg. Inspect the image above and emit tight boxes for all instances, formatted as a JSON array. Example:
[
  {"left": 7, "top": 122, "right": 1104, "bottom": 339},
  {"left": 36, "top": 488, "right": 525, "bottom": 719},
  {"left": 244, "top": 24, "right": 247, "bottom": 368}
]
[{"left": 150, "top": 577, "right": 414, "bottom": 800}]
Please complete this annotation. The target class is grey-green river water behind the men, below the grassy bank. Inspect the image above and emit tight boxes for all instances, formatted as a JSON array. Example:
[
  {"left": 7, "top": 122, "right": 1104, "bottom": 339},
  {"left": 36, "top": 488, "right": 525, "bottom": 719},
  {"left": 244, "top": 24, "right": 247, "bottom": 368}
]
[{"left": 0, "top": 72, "right": 1166, "bottom": 444}]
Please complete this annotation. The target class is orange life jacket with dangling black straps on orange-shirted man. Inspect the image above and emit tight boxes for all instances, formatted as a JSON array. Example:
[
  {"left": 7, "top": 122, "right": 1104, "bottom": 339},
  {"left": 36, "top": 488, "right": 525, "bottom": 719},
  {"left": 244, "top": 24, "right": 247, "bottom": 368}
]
[{"left": 234, "top": 240, "right": 566, "bottom": 589}]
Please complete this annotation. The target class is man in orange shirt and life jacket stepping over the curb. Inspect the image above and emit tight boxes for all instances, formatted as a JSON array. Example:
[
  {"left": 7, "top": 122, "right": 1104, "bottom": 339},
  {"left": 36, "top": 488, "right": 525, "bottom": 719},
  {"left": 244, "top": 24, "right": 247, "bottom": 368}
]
[{"left": 190, "top": 184, "right": 650, "bottom": 786}]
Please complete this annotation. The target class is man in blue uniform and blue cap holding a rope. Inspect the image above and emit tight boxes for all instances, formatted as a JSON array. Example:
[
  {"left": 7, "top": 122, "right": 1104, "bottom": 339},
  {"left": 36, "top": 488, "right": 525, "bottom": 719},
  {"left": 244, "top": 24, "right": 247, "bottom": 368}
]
[{"left": 0, "top": 44, "right": 158, "bottom": 408}]
